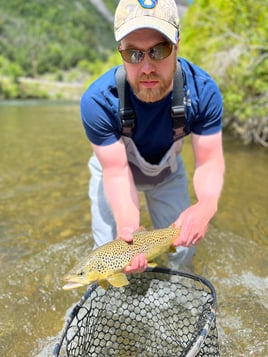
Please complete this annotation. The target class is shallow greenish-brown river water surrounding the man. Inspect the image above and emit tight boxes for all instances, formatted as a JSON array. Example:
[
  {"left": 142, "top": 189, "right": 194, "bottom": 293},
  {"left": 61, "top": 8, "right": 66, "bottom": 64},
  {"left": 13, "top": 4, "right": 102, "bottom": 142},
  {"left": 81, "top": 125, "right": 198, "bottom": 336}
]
[{"left": 0, "top": 102, "right": 268, "bottom": 357}]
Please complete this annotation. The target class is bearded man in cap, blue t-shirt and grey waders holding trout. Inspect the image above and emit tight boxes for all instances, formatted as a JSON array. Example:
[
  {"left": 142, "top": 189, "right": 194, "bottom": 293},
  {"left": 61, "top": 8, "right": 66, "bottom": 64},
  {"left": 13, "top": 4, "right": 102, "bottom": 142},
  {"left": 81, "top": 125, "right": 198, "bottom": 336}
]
[{"left": 81, "top": 0, "right": 224, "bottom": 272}]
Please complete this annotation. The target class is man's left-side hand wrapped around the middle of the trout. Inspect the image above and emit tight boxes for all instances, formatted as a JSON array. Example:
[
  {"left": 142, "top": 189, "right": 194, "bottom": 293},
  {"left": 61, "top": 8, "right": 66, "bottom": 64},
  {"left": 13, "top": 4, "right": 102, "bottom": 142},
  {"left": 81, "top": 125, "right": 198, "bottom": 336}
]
[{"left": 116, "top": 227, "right": 148, "bottom": 274}]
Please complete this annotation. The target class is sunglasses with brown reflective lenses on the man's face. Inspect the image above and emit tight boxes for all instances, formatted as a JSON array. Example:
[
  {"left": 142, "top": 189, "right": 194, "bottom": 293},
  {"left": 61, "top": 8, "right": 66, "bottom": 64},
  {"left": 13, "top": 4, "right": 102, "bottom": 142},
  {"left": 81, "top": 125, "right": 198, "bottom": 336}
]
[{"left": 118, "top": 42, "right": 173, "bottom": 64}]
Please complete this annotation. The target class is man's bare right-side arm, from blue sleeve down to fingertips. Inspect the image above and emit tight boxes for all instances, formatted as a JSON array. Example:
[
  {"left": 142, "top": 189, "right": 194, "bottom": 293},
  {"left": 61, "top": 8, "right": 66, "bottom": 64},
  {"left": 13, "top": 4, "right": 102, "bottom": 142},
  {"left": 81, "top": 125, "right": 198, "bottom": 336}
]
[{"left": 174, "top": 132, "right": 224, "bottom": 247}]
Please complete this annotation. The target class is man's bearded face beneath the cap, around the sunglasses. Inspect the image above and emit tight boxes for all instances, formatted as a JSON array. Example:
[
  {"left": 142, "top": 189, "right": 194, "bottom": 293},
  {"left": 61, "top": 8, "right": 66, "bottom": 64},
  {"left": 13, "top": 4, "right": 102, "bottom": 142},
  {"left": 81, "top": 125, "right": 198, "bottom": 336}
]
[{"left": 119, "top": 29, "right": 178, "bottom": 102}]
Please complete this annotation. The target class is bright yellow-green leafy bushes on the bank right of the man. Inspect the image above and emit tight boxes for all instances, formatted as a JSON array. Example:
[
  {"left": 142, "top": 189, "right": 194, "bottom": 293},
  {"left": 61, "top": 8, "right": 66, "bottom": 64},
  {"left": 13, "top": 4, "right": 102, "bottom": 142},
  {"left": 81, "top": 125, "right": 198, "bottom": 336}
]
[{"left": 180, "top": 0, "right": 268, "bottom": 147}]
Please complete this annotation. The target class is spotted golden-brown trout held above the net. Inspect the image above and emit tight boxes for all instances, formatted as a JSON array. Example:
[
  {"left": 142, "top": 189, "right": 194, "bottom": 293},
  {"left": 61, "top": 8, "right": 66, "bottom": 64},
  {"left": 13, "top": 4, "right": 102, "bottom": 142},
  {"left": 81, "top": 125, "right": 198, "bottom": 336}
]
[{"left": 63, "top": 226, "right": 180, "bottom": 290}]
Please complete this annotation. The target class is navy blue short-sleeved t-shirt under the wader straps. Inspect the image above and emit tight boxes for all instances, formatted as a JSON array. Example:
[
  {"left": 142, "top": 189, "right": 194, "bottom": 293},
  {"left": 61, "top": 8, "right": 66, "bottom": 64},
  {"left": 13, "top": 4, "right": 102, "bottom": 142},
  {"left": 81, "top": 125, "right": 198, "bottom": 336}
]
[{"left": 81, "top": 58, "right": 222, "bottom": 164}]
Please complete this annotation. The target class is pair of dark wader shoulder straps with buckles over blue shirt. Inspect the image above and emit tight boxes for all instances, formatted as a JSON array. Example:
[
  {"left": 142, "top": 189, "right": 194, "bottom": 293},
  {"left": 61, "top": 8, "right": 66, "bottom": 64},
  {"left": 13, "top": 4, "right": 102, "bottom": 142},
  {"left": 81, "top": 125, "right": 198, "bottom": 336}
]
[{"left": 116, "top": 62, "right": 185, "bottom": 141}]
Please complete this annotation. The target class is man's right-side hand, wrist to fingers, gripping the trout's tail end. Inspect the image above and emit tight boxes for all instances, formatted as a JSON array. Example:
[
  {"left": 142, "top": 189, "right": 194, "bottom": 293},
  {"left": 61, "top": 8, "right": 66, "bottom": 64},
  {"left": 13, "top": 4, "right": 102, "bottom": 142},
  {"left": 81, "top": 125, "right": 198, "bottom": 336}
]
[{"left": 174, "top": 202, "right": 216, "bottom": 247}]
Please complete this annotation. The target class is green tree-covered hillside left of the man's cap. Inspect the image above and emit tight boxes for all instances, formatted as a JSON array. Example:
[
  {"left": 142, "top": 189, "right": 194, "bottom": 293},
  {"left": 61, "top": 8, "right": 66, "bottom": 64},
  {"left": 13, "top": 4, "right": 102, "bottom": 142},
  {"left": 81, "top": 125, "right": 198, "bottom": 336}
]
[{"left": 0, "top": 0, "right": 117, "bottom": 77}]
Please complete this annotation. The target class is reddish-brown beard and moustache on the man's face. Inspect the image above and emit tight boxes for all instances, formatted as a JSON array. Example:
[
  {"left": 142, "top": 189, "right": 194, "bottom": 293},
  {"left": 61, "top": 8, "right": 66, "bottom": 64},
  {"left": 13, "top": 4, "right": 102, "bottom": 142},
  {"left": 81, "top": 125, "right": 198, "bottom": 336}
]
[{"left": 129, "top": 64, "right": 176, "bottom": 103}]
